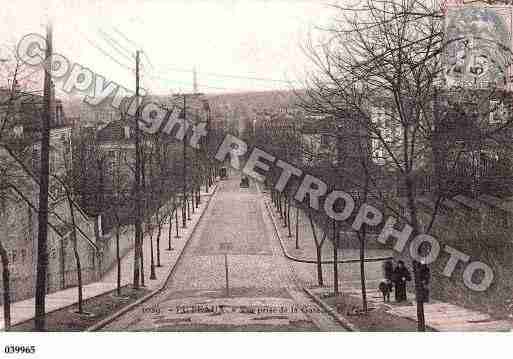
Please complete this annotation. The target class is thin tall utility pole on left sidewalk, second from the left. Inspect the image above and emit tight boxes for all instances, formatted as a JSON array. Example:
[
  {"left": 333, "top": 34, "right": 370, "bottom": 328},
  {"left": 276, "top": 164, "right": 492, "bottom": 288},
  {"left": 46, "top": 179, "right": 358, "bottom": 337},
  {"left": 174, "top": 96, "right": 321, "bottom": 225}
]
[{"left": 133, "top": 50, "right": 143, "bottom": 289}]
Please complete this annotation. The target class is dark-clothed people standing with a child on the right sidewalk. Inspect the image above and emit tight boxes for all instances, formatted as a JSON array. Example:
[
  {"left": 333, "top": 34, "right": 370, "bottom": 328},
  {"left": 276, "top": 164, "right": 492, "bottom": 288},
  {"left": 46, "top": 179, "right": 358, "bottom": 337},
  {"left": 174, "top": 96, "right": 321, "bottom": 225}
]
[{"left": 379, "top": 260, "right": 411, "bottom": 302}]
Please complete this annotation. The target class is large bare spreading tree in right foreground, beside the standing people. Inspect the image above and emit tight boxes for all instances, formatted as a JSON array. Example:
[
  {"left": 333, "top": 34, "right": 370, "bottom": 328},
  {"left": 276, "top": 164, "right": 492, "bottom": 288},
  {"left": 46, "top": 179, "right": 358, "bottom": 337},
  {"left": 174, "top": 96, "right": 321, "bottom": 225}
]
[{"left": 300, "top": 0, "right": 511, "bottom": 331}]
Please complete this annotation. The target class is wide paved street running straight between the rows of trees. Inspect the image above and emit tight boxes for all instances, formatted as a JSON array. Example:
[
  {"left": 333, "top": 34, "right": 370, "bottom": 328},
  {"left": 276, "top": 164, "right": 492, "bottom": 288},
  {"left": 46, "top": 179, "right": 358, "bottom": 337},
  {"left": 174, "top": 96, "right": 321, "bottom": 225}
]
[{"left": 102, "top": 175, "right": 343, "bottom": 331}]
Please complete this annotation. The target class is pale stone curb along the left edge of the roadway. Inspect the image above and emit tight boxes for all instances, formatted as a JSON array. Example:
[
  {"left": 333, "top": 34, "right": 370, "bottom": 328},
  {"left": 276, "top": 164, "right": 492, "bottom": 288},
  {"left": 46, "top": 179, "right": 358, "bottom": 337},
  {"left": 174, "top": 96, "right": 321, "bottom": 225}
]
[{"left": 85, "top": 183, "right": 219, "bottom": 332}]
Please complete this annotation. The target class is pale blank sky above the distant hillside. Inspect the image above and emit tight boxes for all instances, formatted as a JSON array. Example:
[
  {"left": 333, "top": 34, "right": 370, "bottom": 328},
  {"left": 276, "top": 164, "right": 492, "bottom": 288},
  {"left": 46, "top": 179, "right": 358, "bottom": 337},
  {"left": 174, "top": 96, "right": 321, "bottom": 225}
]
[{"left": 0, "top": 0, "right": 340, "bottom": 94}]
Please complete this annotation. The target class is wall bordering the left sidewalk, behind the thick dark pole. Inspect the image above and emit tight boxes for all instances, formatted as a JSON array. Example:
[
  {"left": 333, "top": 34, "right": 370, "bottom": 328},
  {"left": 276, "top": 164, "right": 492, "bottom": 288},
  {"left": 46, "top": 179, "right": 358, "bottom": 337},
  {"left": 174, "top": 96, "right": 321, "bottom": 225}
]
[{"left": 0, "top": 195, "right": 100, "bottom": 303}]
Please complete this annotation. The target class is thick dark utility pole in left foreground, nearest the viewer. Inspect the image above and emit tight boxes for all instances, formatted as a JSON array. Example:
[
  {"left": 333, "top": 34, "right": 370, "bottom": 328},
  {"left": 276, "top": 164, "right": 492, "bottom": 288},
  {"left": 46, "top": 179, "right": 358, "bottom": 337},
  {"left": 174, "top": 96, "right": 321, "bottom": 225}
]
[{"left": 34, "top": 21, "right": 53, "bottom": 331}]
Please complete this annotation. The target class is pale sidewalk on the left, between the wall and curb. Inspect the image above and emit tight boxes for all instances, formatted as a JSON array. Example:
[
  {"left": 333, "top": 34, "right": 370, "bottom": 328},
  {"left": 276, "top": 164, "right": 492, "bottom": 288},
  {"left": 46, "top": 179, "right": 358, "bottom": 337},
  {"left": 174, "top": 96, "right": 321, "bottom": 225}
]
[{"left": 0, "top": 183, "right": 218, "bottom": 330}]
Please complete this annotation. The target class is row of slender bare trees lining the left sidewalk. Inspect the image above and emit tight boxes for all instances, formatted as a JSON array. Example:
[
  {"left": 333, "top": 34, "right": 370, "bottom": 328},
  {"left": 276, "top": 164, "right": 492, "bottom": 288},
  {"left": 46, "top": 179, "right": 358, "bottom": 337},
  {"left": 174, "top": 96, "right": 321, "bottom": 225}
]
[{"left": 0, "top": 41, "right": 221, "bottom": 330}]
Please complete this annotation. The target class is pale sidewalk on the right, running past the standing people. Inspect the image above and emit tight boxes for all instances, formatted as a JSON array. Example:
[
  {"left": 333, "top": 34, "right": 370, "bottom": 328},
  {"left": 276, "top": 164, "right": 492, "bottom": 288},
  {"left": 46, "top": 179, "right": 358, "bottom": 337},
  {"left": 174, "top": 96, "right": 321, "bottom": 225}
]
[{"left": 263, "top": 193, "right": 513, "bottom": 331}]
